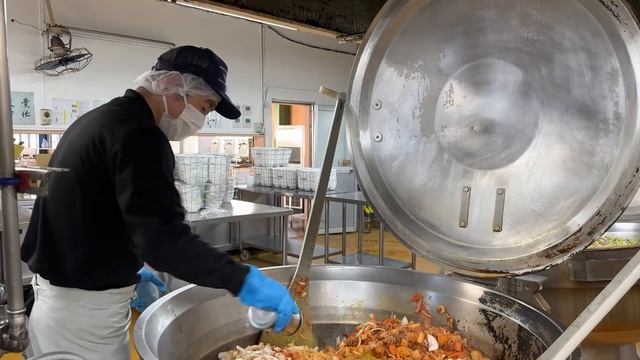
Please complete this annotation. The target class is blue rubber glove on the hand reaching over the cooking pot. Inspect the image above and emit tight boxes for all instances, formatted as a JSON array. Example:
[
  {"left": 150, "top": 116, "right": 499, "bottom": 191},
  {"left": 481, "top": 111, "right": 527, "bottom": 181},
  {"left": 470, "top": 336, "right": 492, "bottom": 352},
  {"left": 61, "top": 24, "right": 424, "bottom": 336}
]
[{"left": 238, "top": 266, "right": 300, "bottom": 332}]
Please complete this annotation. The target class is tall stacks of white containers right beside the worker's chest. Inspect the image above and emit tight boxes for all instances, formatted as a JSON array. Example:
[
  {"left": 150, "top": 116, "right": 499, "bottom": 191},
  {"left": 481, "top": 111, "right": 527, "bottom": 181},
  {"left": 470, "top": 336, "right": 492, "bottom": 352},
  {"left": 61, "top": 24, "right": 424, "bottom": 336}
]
[{"left": 175, "top": 154, "right": 235, "bottom": 212}]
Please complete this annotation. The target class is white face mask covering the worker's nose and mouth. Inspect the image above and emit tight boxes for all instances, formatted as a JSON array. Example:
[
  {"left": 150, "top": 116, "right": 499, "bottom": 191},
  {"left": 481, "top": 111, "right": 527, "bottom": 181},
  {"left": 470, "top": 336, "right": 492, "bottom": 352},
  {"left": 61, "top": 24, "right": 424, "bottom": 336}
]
[{"left": 158, "top": 96, "right": 206, "bottom": 141}]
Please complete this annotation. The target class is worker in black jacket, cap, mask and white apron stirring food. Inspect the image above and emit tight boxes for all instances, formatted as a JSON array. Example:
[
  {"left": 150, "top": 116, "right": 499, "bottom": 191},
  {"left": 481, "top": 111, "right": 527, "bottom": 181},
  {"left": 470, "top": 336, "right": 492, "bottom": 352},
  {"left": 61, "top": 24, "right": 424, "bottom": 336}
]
[{"left": 22, "top": 46, "right": 298, "bottom": 359}]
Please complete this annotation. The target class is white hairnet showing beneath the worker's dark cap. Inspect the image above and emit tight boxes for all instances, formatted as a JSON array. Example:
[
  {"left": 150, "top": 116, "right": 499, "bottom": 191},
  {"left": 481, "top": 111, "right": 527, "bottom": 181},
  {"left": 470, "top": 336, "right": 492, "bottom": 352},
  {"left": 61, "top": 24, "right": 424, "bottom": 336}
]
[{"left": 135, "top": 70, "right": 220, "bottom": 102}]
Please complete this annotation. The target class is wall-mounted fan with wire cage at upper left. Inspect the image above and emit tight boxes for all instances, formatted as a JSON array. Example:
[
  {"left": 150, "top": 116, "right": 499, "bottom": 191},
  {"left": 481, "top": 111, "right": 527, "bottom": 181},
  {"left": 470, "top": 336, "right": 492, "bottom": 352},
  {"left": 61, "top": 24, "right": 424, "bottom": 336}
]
[{"left": 34, "top": 0, "right": 93, "bottom": 76}]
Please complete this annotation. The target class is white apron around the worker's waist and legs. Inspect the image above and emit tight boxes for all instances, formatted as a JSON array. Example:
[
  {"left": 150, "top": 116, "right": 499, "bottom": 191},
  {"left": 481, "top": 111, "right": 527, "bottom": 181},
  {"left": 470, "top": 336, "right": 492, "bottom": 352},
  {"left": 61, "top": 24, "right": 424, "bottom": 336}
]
[{"left": 29, "top": 275, "right": 134, "bottom": 360}]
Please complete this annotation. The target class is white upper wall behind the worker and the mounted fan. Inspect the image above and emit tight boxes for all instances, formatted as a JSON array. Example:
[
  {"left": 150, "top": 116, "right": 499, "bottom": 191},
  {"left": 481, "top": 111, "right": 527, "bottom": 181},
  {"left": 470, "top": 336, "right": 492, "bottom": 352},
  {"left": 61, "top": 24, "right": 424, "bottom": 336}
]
[{"left": 8, "top": 0, "right": 353, "bottom": 141}]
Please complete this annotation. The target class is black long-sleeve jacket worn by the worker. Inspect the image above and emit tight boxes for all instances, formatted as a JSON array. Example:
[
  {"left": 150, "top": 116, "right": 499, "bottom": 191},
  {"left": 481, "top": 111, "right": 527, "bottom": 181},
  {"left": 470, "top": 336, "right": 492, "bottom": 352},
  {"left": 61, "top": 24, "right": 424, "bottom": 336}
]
[{"left": 21, "top": 90, "right": 248, "bottom": 294}]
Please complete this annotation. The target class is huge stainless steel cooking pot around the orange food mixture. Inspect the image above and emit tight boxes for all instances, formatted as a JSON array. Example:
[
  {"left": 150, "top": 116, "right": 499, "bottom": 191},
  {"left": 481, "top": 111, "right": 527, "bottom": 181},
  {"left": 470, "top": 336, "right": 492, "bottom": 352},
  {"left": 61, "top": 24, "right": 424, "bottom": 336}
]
[{"left": 134, "top": 266, "right": 580, "bottom": 360}]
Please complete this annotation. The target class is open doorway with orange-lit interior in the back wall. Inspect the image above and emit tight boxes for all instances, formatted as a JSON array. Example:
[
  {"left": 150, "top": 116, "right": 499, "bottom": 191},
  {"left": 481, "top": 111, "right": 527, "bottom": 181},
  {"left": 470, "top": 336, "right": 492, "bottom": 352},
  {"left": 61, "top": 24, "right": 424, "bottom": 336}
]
[{"left": 271, "top": 101, "right": 313, "bottom": 167}]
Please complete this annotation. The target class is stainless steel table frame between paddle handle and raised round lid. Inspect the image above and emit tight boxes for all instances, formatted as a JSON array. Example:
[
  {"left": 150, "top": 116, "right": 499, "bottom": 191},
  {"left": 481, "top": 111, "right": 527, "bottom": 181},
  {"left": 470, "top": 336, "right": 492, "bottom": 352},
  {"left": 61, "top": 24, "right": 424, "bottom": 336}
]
[{"left": 324, "top": 191, "right": 416, "bottom": 270}]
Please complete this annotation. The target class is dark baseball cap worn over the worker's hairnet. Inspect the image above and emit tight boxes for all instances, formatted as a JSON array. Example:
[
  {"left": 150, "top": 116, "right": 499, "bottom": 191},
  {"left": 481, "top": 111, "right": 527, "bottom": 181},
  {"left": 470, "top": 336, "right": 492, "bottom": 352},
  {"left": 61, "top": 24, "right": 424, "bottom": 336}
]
[{"left": 152, "top": 45, "right": 240, "bottom": 119}]
